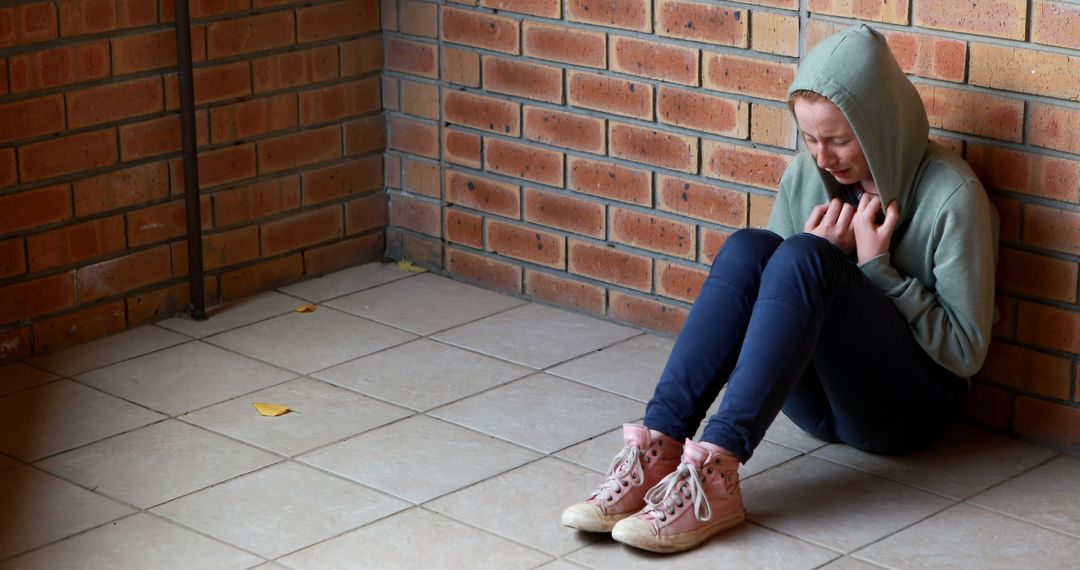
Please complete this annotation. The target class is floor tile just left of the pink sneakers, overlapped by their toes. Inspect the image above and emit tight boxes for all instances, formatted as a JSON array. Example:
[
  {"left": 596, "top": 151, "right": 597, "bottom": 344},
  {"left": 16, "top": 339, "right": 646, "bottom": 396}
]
[{"left": 424, "top": 459, "right": 598, "bottom": 556}]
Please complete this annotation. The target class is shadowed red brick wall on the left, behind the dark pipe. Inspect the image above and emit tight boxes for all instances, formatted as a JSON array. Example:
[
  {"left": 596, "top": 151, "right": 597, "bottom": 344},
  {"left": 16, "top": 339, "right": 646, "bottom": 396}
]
[{"left": 0, "top": 0, "right": 387, "bottom": 356}]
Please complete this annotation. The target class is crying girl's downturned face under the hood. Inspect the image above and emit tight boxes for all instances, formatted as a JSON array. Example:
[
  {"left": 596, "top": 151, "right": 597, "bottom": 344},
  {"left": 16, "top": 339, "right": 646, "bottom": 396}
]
[{"left": 793, "top": 97, "right": 877, "bottom": 194}]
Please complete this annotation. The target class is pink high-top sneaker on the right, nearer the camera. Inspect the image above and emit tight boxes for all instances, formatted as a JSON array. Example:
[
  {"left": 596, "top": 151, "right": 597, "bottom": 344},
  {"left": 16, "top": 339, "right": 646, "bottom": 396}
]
[{"left": 611, "top": 439, "right": 746, "bottom": 553}]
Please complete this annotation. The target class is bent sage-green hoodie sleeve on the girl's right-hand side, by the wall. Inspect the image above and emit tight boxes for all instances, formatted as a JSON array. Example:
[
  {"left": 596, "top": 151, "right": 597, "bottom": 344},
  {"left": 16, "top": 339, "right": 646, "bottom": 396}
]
[{"left": 860, "top": 181, "right": 997, "bottom": 378}]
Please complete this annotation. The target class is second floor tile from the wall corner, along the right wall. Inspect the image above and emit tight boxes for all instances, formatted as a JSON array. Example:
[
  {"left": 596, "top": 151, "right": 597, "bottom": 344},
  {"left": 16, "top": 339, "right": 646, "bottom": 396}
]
[{"left": 326, "top": 273, "right": 526, "bottom": 335}]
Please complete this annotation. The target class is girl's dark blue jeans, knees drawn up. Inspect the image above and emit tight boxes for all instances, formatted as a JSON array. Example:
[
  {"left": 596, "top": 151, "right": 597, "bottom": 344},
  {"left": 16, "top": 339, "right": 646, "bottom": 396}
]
[{"left": 645, "top": 229, "right": 968, "bottom": 463}]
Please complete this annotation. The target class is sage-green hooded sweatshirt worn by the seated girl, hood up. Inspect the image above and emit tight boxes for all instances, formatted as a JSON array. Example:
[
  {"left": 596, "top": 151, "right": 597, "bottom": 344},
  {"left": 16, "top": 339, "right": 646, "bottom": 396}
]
[{"left": 769, "top": 25, "right": 998, "bottom": 378}]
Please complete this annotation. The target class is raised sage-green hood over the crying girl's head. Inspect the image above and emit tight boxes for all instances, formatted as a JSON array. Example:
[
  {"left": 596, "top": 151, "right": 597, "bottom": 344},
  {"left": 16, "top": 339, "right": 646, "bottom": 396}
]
[{"left": 787, "top": 25, "right": 930, "bottom": 219}]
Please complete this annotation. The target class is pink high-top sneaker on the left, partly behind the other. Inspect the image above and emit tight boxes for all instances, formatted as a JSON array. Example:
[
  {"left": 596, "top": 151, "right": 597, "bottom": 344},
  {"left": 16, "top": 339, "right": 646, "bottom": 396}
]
[{"left": 563, "top": 424, "right": 683, "bottom": 532}]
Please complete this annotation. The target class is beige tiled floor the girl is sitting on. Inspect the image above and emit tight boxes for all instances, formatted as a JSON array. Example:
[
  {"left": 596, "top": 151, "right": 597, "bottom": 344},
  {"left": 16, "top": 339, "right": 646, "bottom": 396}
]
[{"left": 0, "top": 264, "right": 1080, "bottom": 570}]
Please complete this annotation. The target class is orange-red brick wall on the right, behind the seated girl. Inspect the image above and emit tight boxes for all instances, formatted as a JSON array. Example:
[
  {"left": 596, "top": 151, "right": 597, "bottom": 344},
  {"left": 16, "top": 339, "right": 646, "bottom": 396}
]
[{"left": 382, "top": 0, "right": 1080, "bottom": 449}]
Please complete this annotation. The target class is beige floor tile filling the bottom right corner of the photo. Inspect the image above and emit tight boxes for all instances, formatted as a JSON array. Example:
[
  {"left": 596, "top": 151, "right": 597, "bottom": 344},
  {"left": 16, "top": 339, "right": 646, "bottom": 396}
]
[{"left": 855, "top": 504, "right": 1080, "bottom": 570}]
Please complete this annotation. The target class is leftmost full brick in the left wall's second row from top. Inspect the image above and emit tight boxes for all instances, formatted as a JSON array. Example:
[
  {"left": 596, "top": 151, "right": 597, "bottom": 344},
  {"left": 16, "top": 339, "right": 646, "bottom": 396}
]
[{"left": 8, "top": 40, "right": 109, "bottom": 93}]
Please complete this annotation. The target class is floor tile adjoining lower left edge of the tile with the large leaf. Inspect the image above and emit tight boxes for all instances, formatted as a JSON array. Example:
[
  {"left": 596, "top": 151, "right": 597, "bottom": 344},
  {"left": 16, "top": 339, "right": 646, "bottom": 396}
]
[{"left": 38, "top": 420, "right": 280, "bottom": 508}]
